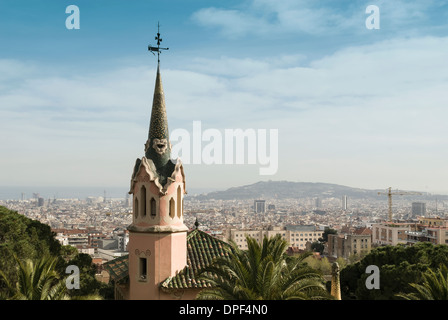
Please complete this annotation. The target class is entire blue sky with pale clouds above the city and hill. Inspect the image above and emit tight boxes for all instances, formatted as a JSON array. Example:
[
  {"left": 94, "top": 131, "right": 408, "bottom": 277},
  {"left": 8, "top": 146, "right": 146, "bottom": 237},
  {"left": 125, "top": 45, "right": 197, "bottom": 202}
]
[{"left": 0, "top": 0, "right": 448, "bottom": 194}]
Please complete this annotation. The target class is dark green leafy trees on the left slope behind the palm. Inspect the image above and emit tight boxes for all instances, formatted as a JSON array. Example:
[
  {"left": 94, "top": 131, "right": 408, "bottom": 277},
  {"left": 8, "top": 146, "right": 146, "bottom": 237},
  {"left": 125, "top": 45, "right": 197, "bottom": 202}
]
[{"left": 0, "top": 206, "right": 110, "bottom": 297}]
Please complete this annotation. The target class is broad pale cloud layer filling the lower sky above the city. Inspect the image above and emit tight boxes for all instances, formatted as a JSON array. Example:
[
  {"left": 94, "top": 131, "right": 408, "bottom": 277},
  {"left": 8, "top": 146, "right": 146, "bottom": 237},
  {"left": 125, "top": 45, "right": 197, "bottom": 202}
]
[{"left": 0, "top": 33, "right": 448, "bottom": 190}]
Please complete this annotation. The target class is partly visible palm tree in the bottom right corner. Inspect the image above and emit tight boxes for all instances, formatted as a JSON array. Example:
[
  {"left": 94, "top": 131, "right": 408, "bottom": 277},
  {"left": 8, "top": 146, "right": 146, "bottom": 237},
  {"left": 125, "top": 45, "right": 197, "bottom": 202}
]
[{"left": 397, "top": 264, "right": 448, "bottom": 300}]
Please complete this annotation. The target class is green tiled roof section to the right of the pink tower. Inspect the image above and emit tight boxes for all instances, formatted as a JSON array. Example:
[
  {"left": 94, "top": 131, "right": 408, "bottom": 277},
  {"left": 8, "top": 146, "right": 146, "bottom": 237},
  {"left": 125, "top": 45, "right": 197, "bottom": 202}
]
[{"left": 161, "top": 229, "right": 229, "bottom": 289}]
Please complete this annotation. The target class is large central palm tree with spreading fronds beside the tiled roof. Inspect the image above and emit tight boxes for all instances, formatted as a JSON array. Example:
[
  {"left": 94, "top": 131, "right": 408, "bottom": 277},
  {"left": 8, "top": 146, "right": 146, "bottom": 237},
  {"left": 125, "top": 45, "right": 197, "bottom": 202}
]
[{"left": 197, "top": 235, "right": 331, "bottom": 300}]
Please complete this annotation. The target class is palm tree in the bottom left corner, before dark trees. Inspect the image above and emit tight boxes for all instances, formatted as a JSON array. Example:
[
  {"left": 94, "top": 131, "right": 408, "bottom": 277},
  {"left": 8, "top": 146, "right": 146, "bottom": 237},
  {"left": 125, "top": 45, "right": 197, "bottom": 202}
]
[{"left": 0, "top": 256, "right": 101, "bottom": 300}]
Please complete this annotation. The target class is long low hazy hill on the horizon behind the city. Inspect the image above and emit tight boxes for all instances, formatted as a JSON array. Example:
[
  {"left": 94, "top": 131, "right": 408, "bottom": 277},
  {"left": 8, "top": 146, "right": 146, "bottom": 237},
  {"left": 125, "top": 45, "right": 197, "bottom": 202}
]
[{"left": 195, "top": 181, "right": 440, "bottom": 200}]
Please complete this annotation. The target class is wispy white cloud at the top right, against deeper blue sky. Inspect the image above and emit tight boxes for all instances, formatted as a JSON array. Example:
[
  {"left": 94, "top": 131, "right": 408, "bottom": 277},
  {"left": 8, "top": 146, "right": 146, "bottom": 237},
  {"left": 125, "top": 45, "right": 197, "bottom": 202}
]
[{"left": 192, "top": 0, "right": 447, "bottom": 38}]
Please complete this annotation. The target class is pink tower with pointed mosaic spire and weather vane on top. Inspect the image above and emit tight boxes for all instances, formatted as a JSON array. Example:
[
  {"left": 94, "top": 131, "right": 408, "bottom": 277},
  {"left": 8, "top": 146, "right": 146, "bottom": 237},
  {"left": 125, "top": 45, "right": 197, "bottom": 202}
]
[{"left": 128, "top": 26, "right": 188, "bottom": 300}]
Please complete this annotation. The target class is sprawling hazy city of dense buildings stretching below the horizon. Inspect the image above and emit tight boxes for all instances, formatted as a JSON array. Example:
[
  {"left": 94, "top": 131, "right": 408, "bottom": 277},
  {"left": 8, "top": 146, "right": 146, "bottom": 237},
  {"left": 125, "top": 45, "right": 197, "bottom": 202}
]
[{"left": 0, "top": 181, "right": 448, "bottom": 262}]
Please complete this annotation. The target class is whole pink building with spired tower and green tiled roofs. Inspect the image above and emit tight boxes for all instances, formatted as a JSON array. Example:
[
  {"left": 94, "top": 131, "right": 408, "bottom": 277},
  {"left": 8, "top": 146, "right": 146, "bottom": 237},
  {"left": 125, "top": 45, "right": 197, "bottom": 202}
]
[{"left": 104, "top": 43, "right": 228, "bottom": 300}]
